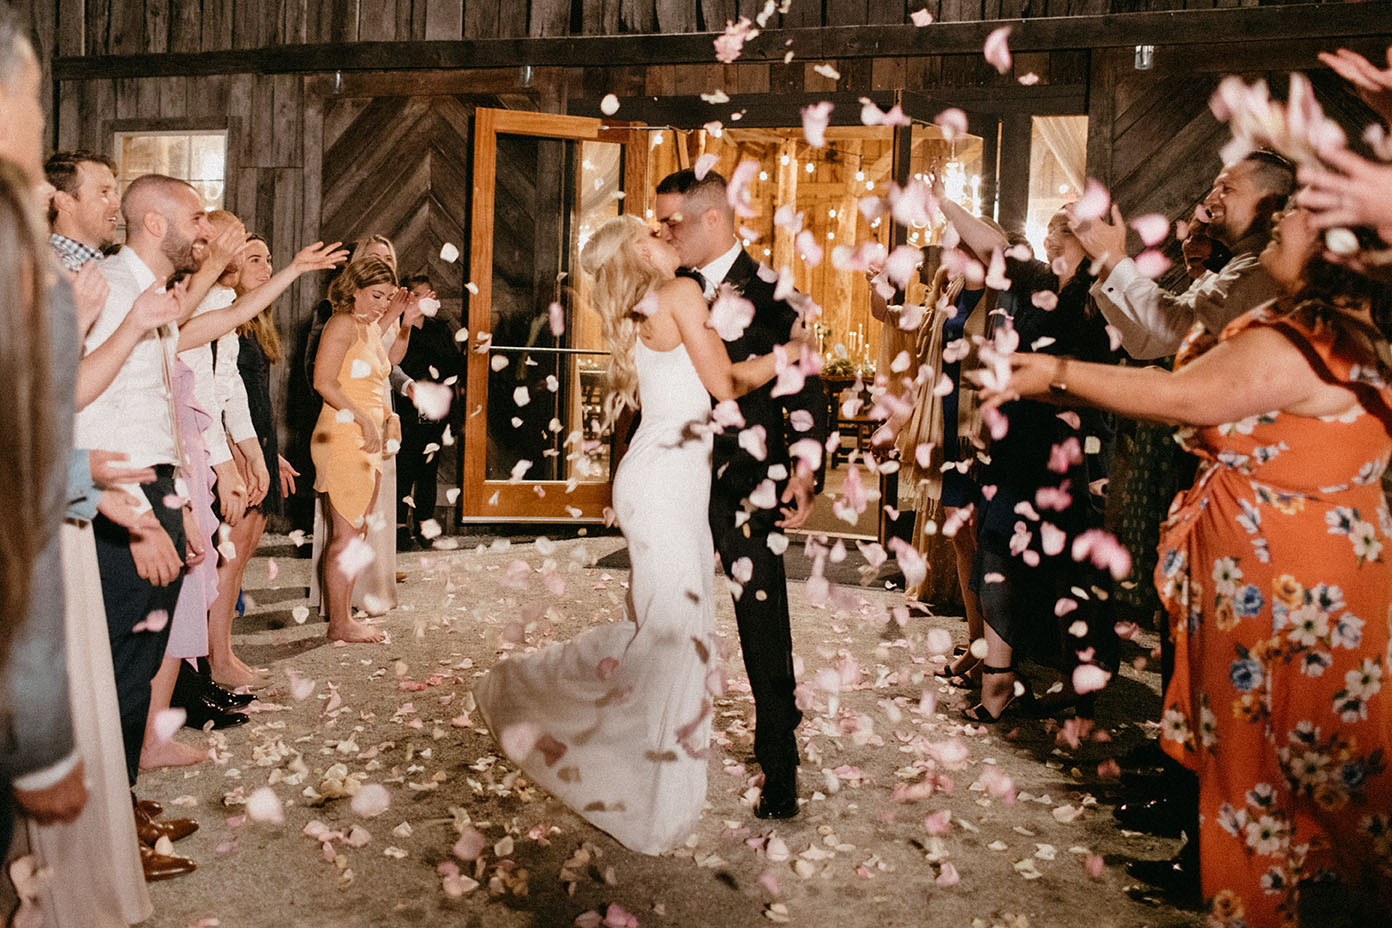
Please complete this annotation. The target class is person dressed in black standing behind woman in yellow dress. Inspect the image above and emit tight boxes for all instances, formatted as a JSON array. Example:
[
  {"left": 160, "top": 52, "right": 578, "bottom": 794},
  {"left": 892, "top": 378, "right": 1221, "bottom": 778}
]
[{"left": 397, "top": 274, "right": 464, "bottom": 550}]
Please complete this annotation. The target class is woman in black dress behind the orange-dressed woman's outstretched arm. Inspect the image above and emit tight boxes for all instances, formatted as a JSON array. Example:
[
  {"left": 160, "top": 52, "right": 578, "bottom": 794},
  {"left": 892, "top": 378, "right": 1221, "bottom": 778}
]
[{"left": 937, "top": 188, "right": 1116, "bottom": 722}]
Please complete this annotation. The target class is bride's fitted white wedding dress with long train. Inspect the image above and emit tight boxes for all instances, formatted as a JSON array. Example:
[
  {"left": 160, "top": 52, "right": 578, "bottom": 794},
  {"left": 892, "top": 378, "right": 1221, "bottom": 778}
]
[{"left": 475, "top": 339, "right": 717, "bottom": 854}]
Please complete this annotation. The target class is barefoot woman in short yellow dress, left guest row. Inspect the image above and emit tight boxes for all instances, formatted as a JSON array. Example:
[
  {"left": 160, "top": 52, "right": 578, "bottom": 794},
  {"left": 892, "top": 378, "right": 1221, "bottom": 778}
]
[{"left": 310, "top": 255, "right": 420, "bottom": 641}]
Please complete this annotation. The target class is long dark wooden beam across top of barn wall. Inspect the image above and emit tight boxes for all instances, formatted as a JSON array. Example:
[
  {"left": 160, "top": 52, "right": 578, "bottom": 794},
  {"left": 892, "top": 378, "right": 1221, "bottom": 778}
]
[{"left": 53, "top": 3, "right": 1389, "bottom": 81}]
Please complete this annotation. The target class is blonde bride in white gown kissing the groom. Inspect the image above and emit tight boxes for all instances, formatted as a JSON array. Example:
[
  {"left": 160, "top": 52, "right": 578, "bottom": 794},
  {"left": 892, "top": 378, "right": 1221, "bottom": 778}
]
[{"left": 475, "top": 216, "right": 796, "bottom": 854}]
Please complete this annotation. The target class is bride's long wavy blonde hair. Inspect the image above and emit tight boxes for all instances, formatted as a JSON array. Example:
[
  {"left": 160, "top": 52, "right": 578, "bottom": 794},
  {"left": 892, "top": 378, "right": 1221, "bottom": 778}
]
[{"left": 580, "top": 216, "right": 661, "bottom": 429}]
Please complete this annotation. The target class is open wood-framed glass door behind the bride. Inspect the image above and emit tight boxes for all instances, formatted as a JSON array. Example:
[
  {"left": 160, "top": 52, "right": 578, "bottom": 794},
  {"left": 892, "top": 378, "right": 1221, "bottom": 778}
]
[{"left": 461, "top": 109, "right": 646, "bottom": 522}]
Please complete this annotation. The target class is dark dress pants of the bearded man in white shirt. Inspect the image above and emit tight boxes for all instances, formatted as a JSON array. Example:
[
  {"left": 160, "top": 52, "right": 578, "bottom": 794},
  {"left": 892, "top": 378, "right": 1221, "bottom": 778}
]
[{"left": 92, "top": 465, "right": 187, "bottom": 786}]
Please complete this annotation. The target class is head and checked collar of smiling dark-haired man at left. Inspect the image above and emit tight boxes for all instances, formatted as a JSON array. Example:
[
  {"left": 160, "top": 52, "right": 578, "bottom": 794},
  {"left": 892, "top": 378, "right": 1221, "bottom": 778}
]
[{"left": 43, "top": 152, "right": 121, "bottom": 271}]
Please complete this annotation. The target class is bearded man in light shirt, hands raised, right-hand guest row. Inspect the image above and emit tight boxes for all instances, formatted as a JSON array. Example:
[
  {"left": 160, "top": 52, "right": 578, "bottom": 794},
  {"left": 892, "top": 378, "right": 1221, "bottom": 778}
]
[{"left": 1072, "top": 150, "right": 1296, "bottom": 359}]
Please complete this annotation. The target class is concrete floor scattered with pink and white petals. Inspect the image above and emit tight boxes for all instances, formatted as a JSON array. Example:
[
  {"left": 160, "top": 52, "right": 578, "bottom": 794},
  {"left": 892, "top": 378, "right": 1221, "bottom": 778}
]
[{"left": 139, "top": 537, "right": 1200, "bottom": 928}]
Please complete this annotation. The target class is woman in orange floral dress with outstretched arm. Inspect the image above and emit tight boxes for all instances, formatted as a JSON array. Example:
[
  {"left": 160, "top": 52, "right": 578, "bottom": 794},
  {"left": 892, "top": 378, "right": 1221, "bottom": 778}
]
[{"left": 985, "top": 210, "right": 1392, "bottom": 928}]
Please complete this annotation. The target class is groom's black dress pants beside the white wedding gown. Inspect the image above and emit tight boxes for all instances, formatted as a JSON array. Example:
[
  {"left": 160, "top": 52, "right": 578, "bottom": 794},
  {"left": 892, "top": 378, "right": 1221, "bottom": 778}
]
[{"left": 710, "top": 450, "right": 802, "bottom": 772}]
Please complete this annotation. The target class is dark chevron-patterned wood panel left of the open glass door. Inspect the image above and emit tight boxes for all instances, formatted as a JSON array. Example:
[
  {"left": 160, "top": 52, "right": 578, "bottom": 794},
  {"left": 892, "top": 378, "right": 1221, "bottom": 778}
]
[{"left": 320, "top": 96, "right": 491, "bottom": 320}]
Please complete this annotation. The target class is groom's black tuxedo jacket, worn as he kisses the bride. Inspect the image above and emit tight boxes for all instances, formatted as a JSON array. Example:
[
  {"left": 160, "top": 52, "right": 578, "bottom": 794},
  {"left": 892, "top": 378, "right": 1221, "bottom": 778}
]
[{"left": 713, "top": 252, "right": 827, "bottom": 497}]
